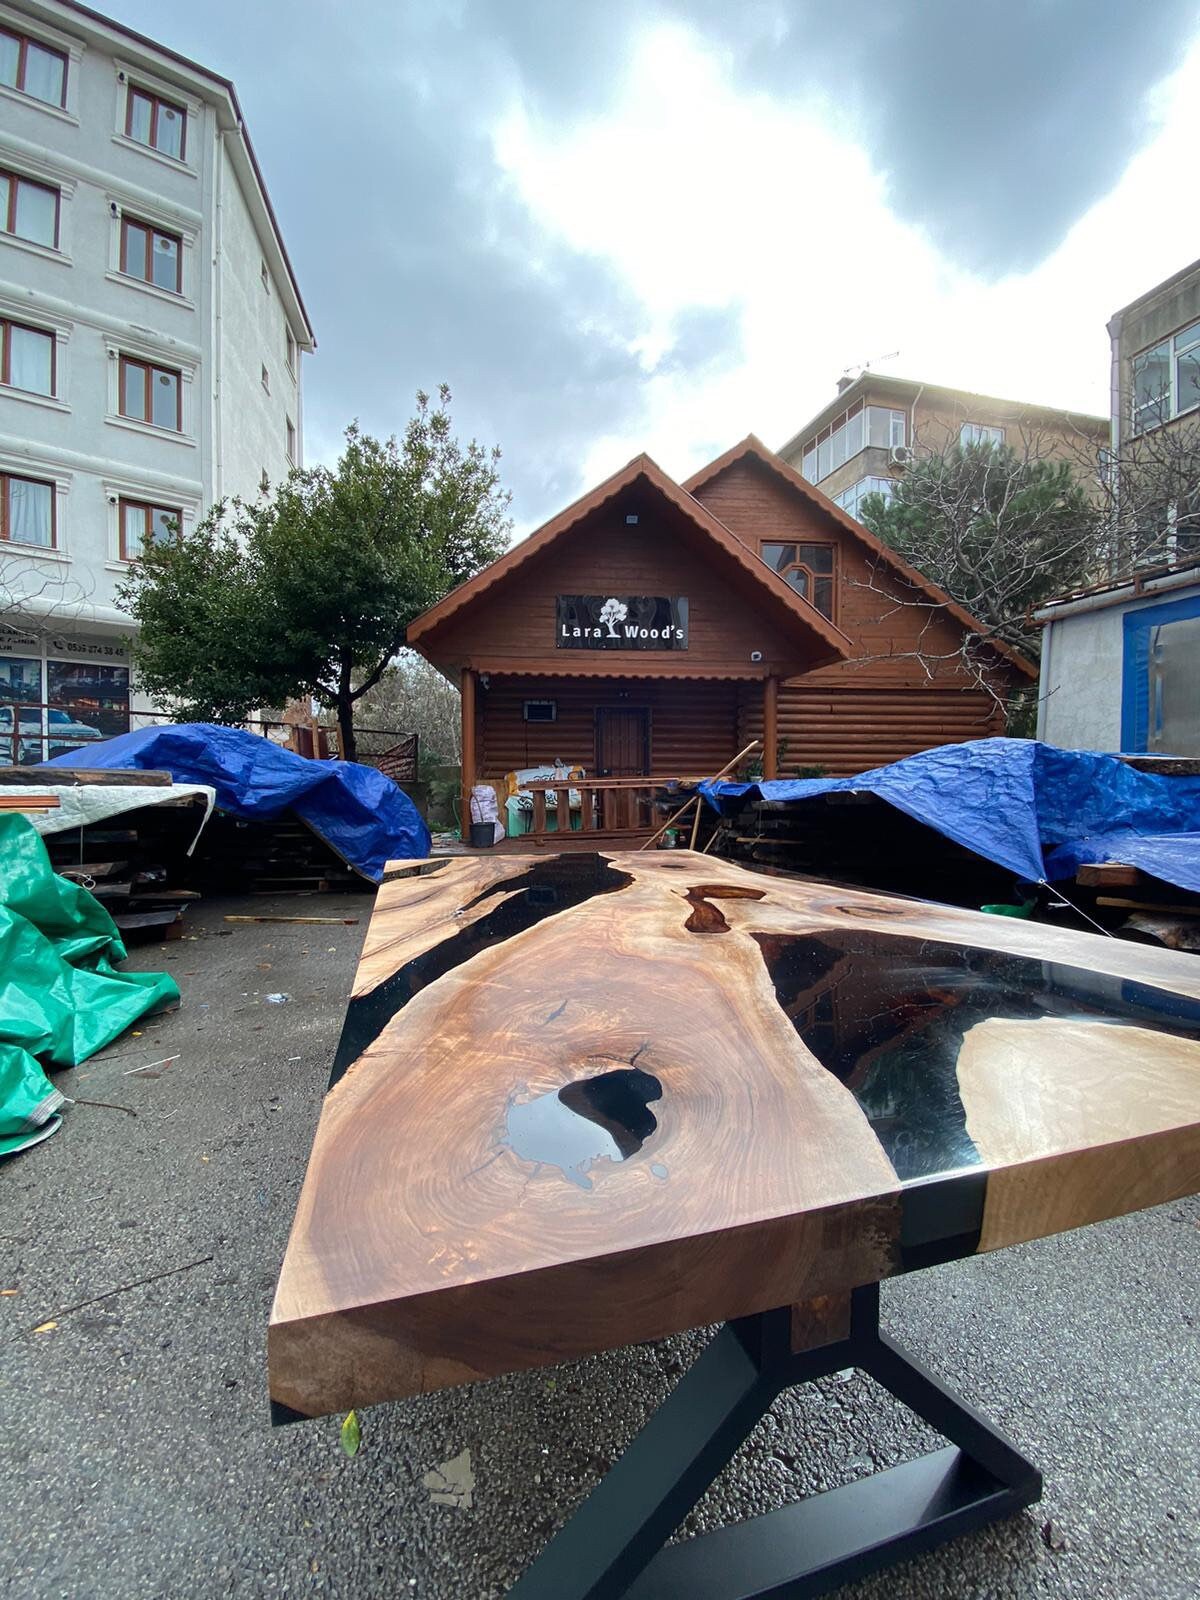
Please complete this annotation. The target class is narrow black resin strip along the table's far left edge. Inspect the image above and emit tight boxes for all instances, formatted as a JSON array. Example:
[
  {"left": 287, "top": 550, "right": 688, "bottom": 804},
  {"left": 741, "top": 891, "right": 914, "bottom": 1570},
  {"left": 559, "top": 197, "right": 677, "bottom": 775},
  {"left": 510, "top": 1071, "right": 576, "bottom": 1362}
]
[{"left": 330, "top": 851, "right": 634, "bottom": 1088}]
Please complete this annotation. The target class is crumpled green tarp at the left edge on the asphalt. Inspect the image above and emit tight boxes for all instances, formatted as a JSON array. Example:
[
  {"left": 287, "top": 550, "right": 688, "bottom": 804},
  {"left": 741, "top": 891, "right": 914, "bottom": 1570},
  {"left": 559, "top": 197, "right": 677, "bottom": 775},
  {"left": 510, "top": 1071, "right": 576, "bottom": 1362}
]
[{"left": 0, "top": 811, "right": 179, "bottom": 1155}]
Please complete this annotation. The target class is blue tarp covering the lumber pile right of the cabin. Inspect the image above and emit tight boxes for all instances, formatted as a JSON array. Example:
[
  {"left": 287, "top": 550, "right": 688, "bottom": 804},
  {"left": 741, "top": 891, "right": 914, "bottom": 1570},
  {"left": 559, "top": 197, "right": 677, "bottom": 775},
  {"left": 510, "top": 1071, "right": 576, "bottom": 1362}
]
[{"left": 701, "top": 739, "right": 1200, "bottom": 893}]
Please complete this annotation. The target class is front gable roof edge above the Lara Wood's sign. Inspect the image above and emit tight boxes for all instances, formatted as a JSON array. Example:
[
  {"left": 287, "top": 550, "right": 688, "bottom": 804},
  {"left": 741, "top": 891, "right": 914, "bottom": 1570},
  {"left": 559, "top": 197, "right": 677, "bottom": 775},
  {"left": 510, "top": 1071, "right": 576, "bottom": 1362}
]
[{"left": 408, "top": 454, "right": 850, "bottom": 661}]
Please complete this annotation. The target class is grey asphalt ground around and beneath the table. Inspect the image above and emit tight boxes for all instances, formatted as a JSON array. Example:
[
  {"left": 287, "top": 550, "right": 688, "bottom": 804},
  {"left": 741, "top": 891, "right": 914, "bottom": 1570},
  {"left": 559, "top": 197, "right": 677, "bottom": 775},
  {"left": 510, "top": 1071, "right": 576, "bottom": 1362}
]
[{"left": 0, "top": 896, "right": 1200, "bottom": 1600}]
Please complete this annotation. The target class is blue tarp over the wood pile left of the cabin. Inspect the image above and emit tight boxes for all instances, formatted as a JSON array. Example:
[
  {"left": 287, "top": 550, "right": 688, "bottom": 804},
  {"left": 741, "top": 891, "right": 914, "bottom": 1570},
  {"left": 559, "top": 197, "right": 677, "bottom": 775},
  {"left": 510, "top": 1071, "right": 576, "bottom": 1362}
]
[{"left": 46, "top": 722, "right": 430, "bottom": 883}]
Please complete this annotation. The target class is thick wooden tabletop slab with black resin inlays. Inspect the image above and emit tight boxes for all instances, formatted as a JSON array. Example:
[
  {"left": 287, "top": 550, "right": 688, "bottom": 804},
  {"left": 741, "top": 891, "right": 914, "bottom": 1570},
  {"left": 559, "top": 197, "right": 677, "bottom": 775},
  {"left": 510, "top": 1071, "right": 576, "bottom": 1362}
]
[{"left": 269, "top": 851, "right": 1200, "bottom": 1416}]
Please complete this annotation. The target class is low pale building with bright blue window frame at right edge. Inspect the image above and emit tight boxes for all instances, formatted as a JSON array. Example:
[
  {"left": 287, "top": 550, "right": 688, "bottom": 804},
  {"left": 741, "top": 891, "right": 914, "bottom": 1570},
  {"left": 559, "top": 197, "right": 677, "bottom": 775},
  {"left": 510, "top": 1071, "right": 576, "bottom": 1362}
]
[{"left": 1035, "top": 562, "right": 1200, "bottom": 755}]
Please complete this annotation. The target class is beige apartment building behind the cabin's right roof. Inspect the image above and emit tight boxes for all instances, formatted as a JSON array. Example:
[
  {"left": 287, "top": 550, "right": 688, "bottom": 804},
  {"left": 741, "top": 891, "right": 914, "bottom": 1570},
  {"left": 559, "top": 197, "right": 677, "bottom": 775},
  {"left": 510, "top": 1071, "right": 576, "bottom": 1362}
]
[{"left": 779, "top": 370, "right": 1109, "bottom": 517}]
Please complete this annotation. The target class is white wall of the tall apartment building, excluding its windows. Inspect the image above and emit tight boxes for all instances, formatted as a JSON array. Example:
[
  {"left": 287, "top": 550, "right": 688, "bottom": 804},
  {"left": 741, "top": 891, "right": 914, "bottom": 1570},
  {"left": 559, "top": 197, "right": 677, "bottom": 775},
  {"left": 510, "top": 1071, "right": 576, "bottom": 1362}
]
[{"left": 0, "top": 0, "right": 307, "bottom": 755}]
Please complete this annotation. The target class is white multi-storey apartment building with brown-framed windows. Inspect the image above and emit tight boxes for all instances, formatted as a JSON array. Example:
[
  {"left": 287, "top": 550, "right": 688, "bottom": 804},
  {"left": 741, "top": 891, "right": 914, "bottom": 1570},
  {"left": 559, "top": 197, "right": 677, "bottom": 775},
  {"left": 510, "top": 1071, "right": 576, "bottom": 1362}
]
[{"left": 0, "top": 0, "right": 314, "bottom": 762}]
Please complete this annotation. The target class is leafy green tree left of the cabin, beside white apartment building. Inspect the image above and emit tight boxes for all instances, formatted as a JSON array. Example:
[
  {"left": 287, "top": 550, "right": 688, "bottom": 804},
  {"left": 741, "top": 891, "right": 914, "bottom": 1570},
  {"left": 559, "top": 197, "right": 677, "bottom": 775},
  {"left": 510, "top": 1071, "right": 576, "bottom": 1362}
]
[{"left": 120, "top": 386, "right": 510, "bottom": 760}]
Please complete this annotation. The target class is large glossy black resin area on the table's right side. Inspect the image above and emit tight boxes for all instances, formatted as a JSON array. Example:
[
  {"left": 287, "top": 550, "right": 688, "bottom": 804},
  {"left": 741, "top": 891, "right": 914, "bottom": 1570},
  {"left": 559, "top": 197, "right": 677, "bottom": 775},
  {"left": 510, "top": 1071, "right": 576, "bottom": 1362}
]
[{"left": 755, "top": 928, "right": 1200, "bottom": 1179}]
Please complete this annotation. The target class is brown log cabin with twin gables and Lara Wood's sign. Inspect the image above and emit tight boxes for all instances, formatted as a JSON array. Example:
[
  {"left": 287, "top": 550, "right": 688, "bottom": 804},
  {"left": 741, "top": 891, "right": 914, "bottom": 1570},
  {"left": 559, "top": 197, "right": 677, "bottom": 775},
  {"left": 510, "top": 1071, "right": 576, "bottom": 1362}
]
[{"left": 408, "top": 437, "right": 1035, "bottom": 838}]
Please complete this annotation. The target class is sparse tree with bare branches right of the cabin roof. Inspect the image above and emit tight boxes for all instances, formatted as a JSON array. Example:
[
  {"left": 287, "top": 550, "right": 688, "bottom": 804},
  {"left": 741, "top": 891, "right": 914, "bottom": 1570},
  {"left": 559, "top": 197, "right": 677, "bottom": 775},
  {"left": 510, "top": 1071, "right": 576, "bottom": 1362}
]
[{"left": 861, "top": 442, "right": 1104, "bottom": 658}]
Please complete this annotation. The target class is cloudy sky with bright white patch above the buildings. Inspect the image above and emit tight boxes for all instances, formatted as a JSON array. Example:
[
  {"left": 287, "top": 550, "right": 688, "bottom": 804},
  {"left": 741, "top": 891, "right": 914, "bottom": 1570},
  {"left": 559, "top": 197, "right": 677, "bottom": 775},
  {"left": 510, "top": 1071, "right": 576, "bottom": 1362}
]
[{"left": 112, "top": 0, "right": 1200, "bottom": 528}]
